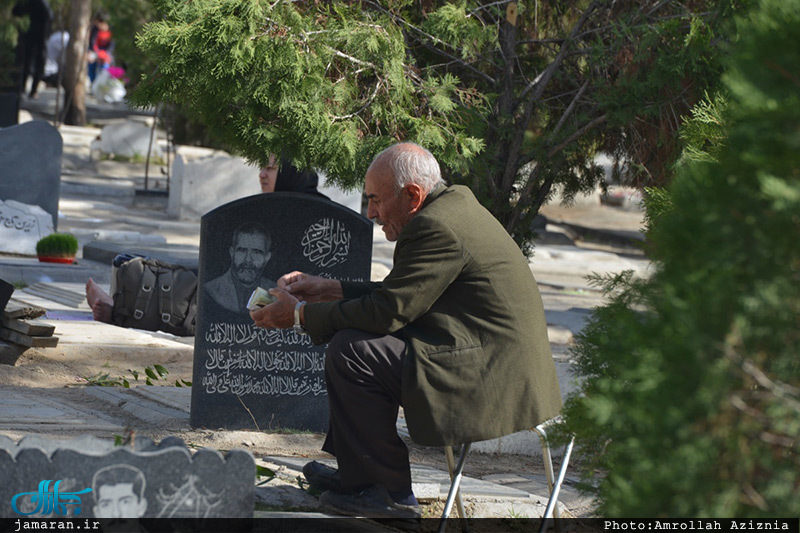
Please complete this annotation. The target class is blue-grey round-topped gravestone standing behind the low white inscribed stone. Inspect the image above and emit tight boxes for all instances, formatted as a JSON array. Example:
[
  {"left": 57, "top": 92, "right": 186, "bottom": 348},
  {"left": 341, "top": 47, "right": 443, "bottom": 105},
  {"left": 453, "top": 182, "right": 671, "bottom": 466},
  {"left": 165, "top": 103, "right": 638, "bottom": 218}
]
[{"left": 0, "top": 120, "right": 64, "bottom": 229}]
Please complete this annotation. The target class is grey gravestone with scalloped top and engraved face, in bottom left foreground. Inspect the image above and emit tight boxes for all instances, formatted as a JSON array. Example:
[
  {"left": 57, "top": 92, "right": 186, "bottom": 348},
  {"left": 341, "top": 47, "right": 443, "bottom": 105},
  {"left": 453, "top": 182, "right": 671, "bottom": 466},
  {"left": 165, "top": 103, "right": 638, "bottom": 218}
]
[{"left": 0, "top": 436, "right": 256, "bottom": 519}]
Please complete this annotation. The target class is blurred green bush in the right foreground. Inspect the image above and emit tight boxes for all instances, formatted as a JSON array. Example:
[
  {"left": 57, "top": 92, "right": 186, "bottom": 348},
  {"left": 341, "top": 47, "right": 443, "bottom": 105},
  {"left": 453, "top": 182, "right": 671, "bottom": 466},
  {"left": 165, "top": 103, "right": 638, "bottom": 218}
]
[{"left": 565, "top": 0, "right": 800, "bottom": 517}]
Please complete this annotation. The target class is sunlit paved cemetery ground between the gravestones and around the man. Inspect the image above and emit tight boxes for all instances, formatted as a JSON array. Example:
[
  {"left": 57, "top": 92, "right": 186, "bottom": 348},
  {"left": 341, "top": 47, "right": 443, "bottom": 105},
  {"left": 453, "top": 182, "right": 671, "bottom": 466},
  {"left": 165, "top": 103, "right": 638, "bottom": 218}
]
[{"left": 0, "top": 91, "right": 648, "bottom": 517}]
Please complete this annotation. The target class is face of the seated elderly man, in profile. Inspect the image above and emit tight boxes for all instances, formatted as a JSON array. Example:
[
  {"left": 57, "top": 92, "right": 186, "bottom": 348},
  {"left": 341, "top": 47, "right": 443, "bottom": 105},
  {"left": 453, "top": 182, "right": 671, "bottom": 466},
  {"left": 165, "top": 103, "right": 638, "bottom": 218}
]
[{"left": 364, "top": 164, "right": 413, "bottom": 241}]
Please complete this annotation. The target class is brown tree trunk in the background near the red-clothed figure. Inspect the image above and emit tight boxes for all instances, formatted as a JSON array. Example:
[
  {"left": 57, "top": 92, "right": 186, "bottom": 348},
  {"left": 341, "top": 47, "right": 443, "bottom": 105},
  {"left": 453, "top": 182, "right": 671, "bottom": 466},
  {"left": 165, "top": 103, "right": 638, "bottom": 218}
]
[{"left": 64, "top": 0, "right": 92, "bottom": 126}]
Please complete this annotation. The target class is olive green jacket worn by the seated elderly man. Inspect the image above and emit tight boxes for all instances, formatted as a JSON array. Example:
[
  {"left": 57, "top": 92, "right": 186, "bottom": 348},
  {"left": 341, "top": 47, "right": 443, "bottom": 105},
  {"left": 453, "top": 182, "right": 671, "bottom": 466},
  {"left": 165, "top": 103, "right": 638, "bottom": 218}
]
[{"left": 304, "top": 185, "right": 561, "bottom": 446}]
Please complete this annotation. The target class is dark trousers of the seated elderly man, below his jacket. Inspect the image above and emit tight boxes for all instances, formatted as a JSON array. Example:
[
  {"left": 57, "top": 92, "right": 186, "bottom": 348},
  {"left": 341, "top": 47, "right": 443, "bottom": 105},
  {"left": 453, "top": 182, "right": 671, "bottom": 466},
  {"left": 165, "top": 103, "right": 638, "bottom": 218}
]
[{"left": 322, "top": 329, "right": 411, "bottom": 491}]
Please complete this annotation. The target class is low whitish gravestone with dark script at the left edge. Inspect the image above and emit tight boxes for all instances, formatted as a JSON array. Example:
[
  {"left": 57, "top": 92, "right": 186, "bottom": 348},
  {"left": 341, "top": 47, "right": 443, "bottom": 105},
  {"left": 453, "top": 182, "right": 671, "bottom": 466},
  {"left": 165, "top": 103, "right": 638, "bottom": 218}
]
[{"left": 0, "top": 200, "right": 55, "bottom": 255}]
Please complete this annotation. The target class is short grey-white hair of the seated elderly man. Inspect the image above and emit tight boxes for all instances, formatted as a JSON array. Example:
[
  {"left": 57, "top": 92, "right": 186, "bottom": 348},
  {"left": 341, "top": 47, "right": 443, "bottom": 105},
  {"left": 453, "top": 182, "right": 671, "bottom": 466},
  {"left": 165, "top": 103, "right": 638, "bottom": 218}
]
[{"left": 370, "top": 143, "right": 444, "bottom": 194}]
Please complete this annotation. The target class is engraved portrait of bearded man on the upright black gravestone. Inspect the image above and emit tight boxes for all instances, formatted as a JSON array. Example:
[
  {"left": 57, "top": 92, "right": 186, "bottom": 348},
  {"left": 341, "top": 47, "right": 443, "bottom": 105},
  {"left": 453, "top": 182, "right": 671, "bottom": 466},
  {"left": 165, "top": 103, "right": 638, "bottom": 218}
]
[{"left": 205, "top": 222, "right": 277, "bottom": 313}]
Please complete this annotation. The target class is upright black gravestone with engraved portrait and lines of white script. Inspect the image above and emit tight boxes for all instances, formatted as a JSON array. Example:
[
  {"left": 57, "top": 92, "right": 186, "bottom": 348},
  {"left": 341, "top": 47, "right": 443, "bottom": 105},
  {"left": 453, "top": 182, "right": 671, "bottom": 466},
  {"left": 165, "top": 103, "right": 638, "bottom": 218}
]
[{"left": 190, "top": 193, "right": 372, "bottom": 432}]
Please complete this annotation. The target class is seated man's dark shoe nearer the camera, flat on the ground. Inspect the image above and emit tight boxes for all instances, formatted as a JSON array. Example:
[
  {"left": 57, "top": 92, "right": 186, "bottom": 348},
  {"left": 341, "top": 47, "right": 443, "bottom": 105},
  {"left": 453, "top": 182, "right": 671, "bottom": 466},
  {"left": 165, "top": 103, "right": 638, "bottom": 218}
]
[{"left": 319, "top": 485, "right": 422, "bottom": 527}]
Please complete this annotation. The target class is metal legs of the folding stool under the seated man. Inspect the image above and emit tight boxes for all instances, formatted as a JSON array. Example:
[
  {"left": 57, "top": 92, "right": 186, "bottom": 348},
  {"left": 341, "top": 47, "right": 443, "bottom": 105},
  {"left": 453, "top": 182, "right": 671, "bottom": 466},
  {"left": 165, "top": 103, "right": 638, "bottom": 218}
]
[{"left": 439, "top": 416, "right": 575, "bottom": 533}]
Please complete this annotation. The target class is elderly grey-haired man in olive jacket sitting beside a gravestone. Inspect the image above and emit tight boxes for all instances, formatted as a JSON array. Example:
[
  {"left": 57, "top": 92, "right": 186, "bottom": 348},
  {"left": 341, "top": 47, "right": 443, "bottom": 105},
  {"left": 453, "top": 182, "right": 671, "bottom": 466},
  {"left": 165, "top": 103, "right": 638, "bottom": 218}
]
[{"left": 251, "top": 143, "right": 561, "bottom": 519}]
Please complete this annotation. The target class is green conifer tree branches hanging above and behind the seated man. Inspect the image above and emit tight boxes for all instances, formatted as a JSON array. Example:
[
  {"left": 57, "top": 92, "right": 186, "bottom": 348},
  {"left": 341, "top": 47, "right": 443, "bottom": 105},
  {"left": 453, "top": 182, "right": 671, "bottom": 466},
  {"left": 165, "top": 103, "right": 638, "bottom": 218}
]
[{"left": 132, "top": 0, "right": 749, "bottom": 251}]
